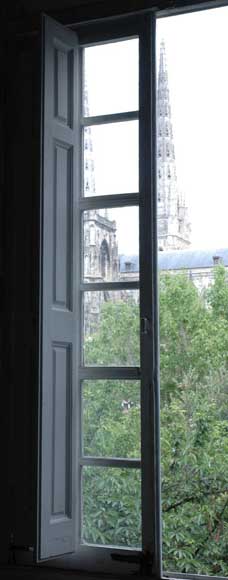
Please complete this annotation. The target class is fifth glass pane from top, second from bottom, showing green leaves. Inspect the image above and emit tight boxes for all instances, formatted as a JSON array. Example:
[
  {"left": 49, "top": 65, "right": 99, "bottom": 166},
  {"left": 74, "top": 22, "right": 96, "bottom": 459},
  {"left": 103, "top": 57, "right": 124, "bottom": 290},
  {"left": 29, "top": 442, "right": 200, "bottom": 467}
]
[{"left": 82, "top": 380, "right": 140, "bottom": 459}]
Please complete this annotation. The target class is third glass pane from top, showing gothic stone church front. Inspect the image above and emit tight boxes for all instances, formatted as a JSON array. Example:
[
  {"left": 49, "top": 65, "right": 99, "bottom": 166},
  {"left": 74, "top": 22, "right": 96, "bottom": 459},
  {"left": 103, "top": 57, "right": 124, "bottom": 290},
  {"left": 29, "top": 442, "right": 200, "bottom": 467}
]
[{"left": 83, "top": 207, "right": 139, "bottom": 282}]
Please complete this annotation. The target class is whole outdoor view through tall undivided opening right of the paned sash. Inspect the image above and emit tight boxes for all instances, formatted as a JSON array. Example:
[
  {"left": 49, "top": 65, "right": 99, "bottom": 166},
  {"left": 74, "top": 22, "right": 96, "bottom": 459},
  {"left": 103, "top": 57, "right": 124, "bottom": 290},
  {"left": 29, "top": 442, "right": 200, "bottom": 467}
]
[{"left": 157, "top": 7, "right": 228, "bottom": 577}]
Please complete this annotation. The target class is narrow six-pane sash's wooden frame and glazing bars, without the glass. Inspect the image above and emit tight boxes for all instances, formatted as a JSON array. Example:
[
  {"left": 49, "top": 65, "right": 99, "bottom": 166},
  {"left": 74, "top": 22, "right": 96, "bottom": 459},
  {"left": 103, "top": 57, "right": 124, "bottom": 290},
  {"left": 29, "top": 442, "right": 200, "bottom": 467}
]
[{"left": 72, "top": 15, "right": 161, "bottom": 576}]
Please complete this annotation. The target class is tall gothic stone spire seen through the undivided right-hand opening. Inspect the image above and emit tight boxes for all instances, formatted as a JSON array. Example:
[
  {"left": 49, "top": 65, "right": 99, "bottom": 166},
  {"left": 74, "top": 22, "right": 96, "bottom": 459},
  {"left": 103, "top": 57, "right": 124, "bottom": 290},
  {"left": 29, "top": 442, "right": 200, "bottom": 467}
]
[{"left": 157, "top": 41, "right": 191, "bottom": 250}]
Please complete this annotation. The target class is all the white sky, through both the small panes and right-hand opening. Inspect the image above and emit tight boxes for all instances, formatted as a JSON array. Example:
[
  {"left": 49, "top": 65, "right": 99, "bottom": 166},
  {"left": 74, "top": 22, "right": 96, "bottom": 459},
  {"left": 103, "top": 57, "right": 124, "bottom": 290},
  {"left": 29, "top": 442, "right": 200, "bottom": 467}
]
[{"left": 85, "top": 7, "right": 228, "bottom": 254}]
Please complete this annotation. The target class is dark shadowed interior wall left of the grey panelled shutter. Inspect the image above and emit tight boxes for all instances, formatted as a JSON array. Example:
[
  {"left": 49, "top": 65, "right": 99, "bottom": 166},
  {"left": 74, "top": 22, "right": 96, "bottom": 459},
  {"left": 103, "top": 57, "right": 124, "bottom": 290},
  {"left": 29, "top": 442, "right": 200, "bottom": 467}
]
[{"left": 2, "top": 29, "right": 40, "bottom": 560}]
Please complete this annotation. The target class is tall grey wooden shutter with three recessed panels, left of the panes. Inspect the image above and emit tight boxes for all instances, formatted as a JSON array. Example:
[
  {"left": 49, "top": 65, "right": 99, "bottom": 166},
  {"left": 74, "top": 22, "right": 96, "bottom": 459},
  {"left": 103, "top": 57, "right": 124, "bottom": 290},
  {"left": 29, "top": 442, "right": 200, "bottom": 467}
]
[{"left": 38, "top": 16, "right": 79, "bottom": 559}]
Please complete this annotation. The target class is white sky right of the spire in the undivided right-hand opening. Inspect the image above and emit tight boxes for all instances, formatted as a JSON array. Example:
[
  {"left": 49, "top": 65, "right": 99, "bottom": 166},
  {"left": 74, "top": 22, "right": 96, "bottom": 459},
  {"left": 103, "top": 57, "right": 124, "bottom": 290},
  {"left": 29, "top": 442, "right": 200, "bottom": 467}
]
[{"left": 157, "top": 7, "right": 228, "bottom": 248}]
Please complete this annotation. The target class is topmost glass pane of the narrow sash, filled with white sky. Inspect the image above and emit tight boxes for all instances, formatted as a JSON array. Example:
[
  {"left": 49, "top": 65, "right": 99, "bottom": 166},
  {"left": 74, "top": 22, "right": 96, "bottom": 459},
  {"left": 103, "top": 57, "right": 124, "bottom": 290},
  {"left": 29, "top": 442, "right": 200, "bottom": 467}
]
[{"left": 83, "top": 38, "right": 139, "bottom": 116}]
